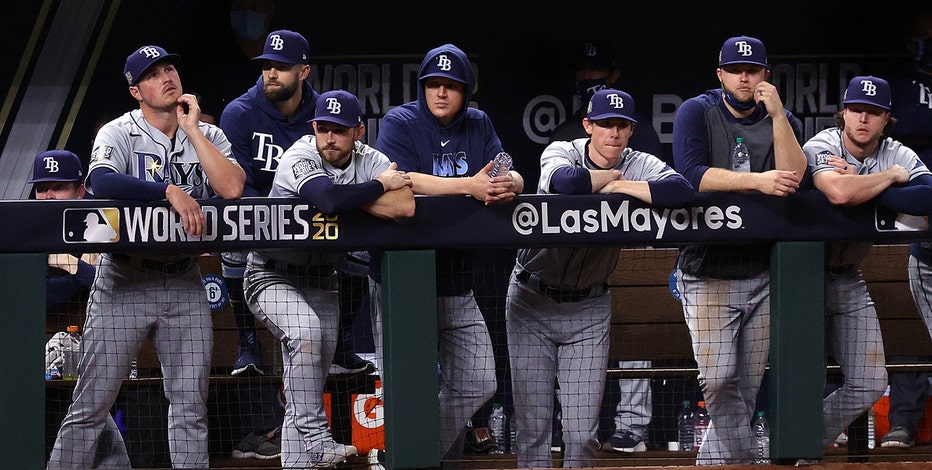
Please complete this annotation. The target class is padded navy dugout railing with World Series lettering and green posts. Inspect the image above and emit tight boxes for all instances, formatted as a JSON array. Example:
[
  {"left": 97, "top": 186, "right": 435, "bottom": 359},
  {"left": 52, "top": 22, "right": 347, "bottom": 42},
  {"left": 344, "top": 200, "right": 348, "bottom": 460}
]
[{"left": 0, "top": 191, "right": 930, "bottom": 468}]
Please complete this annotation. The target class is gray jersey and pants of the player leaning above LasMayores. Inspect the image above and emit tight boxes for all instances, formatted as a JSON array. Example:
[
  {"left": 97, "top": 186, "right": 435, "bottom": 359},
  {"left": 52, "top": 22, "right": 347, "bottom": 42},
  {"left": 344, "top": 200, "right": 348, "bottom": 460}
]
[{"left": 506, "top": 138, "right": 678, "bottom": 468}]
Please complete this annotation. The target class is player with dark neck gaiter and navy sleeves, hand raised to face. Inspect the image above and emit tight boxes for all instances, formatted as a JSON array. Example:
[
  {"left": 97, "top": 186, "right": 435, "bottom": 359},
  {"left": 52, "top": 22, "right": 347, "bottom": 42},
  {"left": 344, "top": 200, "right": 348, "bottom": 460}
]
[{"left": 673, "top": 36, "right": 808, "bottom": 465}]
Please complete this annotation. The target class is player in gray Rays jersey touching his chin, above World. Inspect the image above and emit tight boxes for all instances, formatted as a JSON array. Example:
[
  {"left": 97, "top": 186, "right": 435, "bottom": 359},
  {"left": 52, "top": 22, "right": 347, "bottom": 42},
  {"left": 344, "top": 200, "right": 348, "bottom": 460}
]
[{"left": 48, "top": 45, "right": 246, "bottom": 469}]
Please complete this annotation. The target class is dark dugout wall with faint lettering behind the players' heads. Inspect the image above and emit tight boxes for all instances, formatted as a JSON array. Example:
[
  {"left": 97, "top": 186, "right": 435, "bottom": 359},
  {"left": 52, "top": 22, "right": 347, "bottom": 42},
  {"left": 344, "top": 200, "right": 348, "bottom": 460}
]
[{"left": 0, "top": 0, "right": 927, "bottom": 192}]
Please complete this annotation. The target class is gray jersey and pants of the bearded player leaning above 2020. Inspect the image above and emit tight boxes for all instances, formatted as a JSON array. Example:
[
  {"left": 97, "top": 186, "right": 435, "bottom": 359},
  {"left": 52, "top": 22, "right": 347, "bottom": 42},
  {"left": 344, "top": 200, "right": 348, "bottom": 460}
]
[{"left": 244, "top": 135, "right": 391, "bottom": 468}]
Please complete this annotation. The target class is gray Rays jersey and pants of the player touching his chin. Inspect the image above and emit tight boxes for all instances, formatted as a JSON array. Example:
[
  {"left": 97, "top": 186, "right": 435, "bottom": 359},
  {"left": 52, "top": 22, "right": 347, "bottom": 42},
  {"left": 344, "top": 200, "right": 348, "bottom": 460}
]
[{"left": 48, "top": 109, "right": 236, "bottom": 468}]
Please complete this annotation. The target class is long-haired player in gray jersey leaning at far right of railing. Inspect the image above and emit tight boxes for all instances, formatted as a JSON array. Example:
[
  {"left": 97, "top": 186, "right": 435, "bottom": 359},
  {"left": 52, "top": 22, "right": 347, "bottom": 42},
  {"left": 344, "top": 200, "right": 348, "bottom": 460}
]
[{"left": 803, "top": 76, "right": 932, "bottom": 454}]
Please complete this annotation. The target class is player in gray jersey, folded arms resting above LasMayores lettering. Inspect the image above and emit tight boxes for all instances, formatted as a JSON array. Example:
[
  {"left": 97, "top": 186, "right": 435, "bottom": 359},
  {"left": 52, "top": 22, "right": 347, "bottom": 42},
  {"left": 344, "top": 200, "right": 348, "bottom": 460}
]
[{"left": 506, "top": 88, "right": 694, "bottom": 468}]
